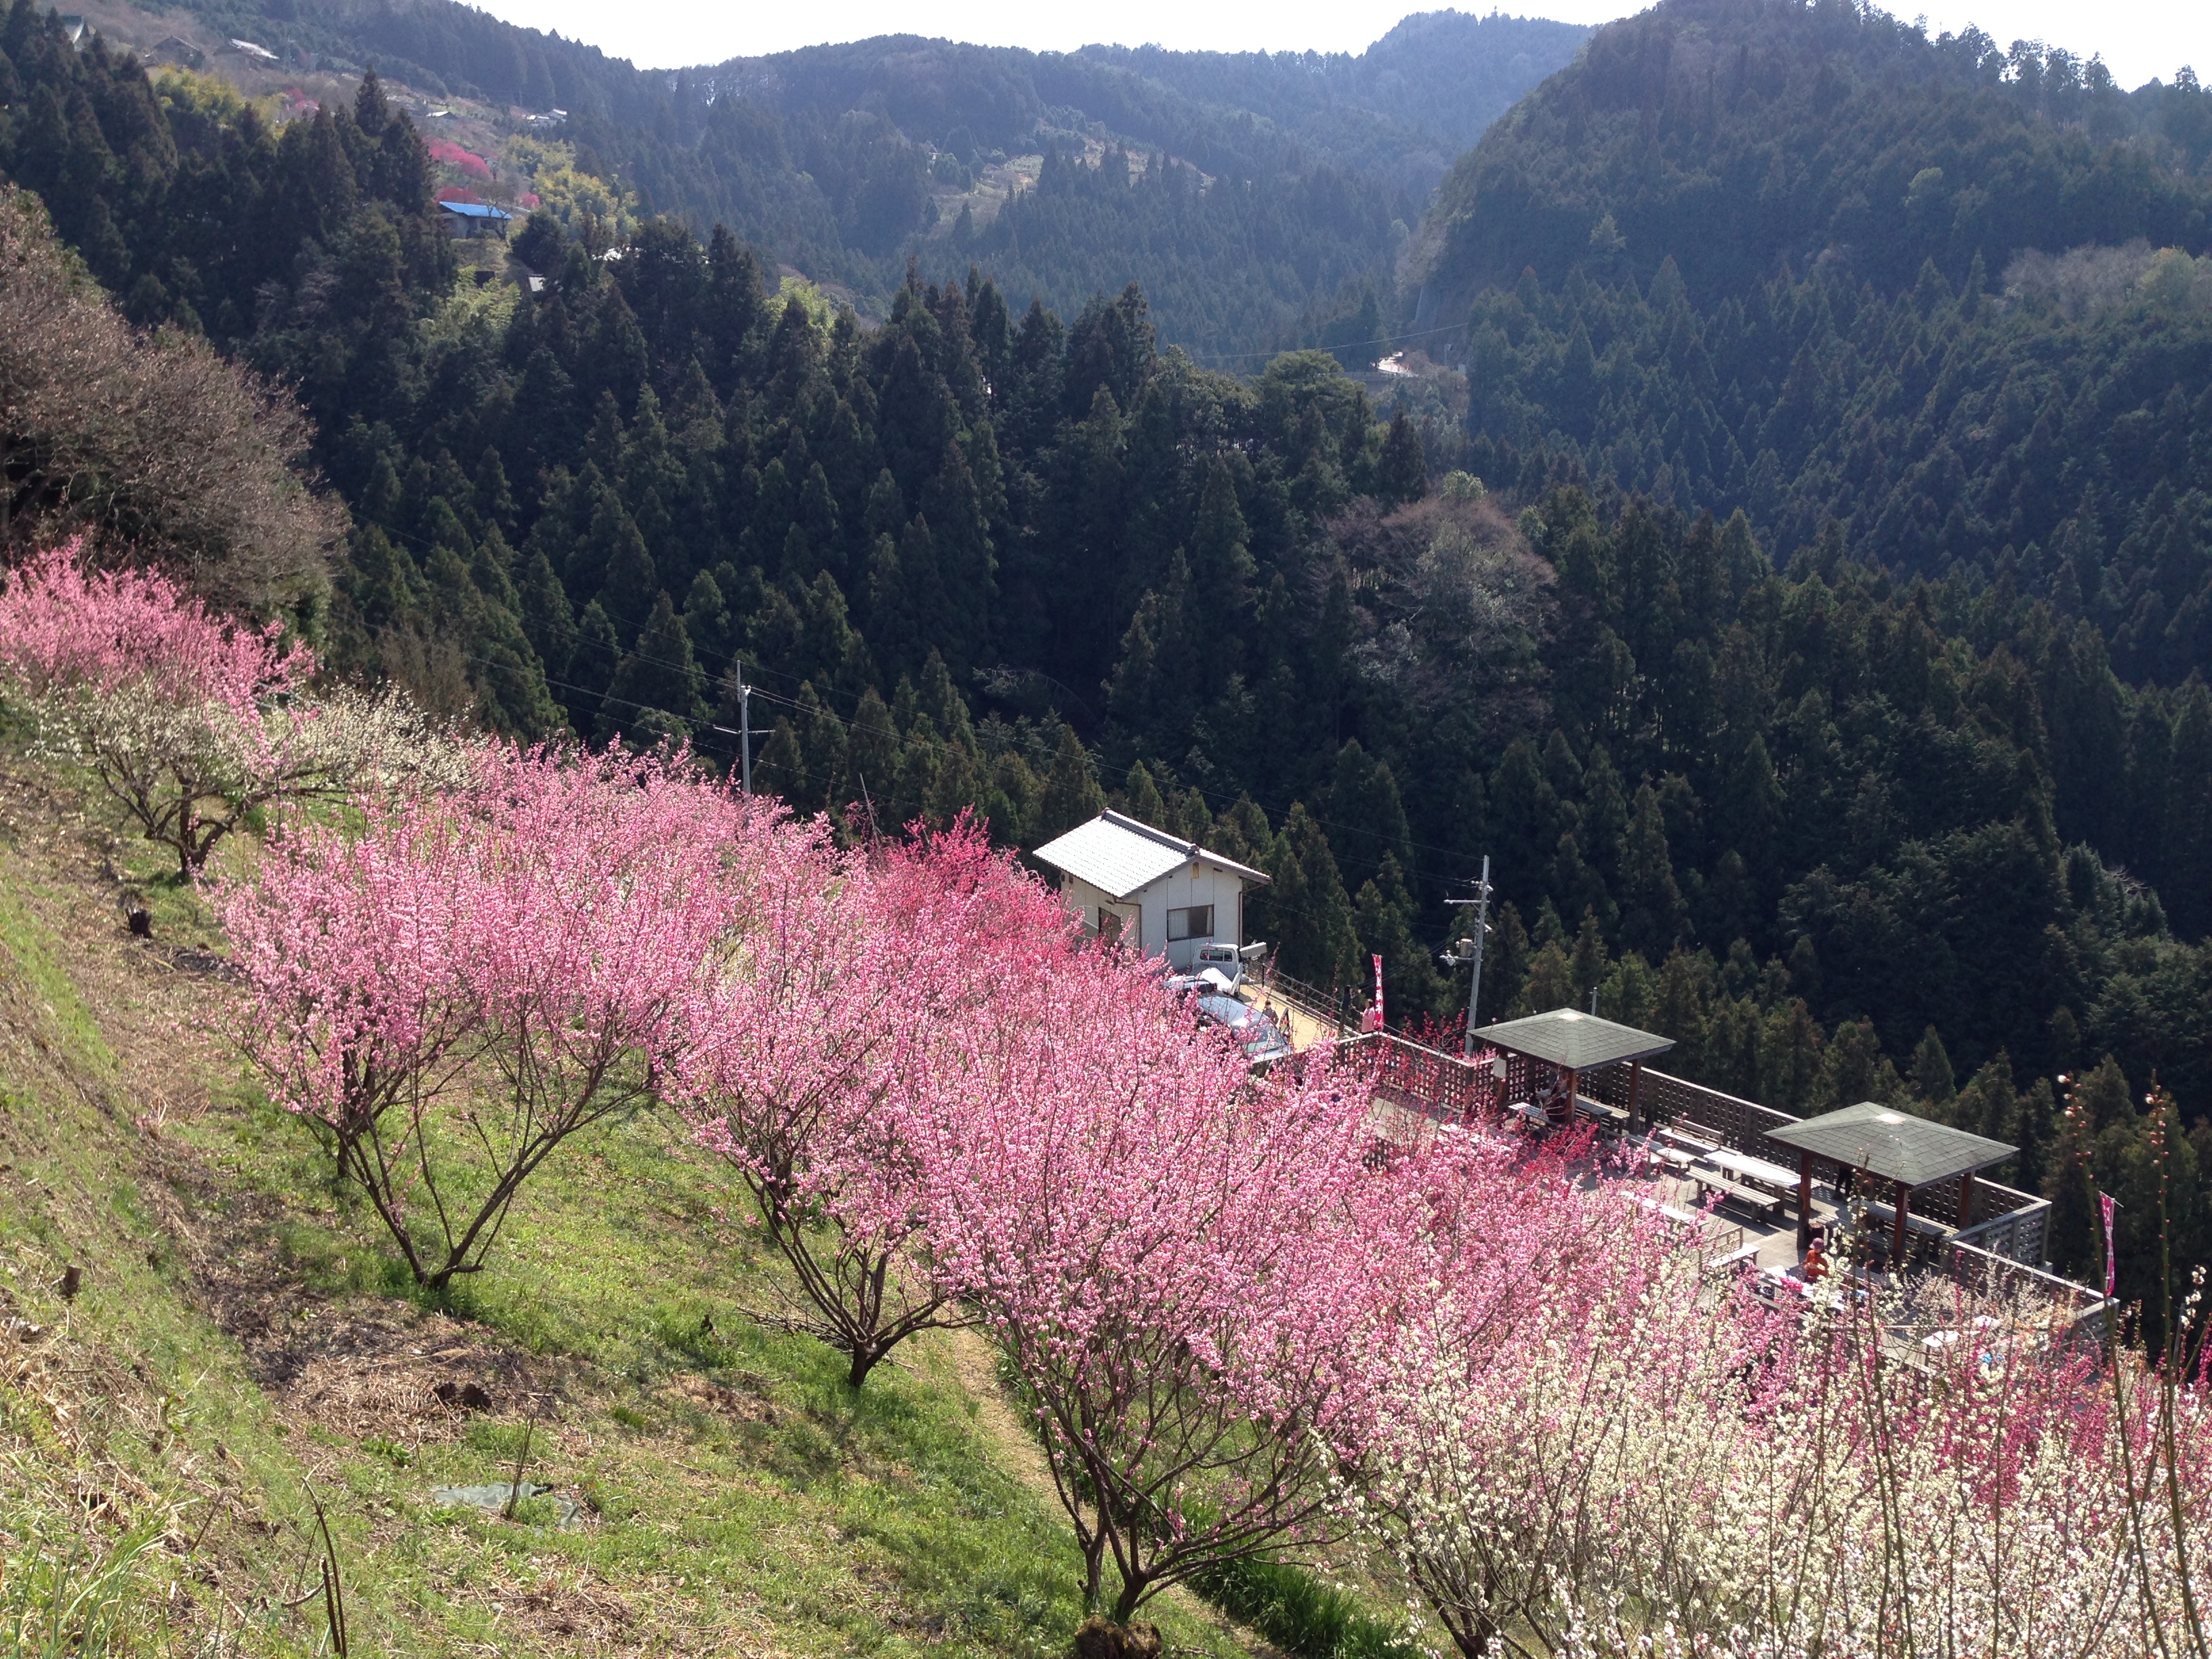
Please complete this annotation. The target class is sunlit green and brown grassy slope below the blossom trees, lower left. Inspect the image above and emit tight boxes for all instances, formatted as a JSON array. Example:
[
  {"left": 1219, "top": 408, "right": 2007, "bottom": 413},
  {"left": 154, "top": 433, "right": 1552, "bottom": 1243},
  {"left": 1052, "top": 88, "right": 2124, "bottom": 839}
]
[{"left": 0, "top": 763, "right": 1283, "bottom": 1654}]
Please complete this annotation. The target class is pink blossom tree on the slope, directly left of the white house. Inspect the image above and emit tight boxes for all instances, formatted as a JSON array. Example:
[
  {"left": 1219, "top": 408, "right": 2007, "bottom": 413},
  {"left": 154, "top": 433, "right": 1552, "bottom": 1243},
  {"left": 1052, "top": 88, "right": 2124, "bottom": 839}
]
[{"left": 677, "top": 823, "right": 1069, "bottom": 1389}]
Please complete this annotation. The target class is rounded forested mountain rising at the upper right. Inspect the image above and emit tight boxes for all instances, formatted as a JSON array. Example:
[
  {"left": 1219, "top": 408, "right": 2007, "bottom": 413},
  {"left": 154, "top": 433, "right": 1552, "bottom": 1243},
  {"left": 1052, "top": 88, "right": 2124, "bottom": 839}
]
[{"left": 1422, "top": 0, "right": 2212, "bottom": 615}]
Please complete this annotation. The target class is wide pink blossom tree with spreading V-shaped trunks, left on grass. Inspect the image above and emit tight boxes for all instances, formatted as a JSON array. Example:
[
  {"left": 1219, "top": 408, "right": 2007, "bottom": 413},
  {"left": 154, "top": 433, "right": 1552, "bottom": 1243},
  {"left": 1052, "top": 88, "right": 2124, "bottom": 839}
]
[{"left": 219, "top": 750, "right": 756, "bottom": 1290}]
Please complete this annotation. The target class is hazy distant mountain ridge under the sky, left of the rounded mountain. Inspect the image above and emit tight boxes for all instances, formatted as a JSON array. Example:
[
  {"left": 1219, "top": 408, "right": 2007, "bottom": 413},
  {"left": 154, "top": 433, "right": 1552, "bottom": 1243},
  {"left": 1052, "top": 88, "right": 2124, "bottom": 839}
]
[{"left": 151, "top": 0, "right": 1589, "bottom": 356}]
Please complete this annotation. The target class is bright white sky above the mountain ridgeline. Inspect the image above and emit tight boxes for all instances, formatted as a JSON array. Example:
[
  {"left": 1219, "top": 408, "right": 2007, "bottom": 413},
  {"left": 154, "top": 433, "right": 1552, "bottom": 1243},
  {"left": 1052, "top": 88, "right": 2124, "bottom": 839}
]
[{"left": 476, "top": 0, "right": 2212, "bottom": 86}]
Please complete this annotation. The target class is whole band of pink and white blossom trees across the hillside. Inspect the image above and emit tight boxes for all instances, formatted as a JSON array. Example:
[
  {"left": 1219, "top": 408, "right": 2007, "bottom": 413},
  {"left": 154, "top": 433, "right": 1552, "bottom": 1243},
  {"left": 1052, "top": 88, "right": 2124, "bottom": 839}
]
[{"left": 13, "top": 541, "right": 2212, "bottom": 1659}]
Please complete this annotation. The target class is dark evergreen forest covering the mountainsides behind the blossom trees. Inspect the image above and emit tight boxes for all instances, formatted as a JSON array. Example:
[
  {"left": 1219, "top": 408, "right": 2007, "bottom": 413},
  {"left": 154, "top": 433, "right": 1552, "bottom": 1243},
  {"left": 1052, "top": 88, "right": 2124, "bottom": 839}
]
[{"left": 13, "top": 0, "right": 2212, "bottom": 1294}]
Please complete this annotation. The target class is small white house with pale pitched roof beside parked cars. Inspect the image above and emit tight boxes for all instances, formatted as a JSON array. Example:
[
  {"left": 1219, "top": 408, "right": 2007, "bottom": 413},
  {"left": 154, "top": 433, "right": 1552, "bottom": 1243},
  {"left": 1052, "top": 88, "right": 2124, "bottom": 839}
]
[{"left": 1036, "top": 812, "right": 1267, "bottom": 973}]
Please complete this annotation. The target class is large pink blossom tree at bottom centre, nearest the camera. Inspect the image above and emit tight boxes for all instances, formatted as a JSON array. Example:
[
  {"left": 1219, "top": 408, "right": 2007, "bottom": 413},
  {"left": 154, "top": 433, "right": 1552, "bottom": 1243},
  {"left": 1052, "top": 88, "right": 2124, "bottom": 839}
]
[{"left": 916, "top": 951, "right": 1425, "bottom": 1622}]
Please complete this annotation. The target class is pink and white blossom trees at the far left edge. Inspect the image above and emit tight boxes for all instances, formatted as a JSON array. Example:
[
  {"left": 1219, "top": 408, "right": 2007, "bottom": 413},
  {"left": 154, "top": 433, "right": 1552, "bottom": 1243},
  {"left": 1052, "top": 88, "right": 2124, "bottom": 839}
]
[{"left": 0, "top": 539, "right": 460, "bottom": 878}]
